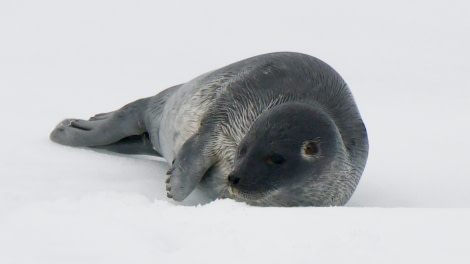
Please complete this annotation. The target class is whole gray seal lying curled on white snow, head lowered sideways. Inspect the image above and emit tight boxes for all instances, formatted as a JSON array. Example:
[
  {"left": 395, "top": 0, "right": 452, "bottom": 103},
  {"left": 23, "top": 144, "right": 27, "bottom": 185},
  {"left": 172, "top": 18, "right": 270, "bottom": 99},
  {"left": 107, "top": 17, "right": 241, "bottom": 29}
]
[{"left": 50, "top": 52, "right": 369, "bottom": 206}]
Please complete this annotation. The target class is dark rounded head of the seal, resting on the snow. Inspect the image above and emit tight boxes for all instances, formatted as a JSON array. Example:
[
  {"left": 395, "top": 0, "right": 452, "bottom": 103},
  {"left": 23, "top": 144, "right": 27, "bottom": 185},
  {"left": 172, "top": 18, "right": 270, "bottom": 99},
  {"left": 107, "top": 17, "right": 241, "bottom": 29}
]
[{"left": 228, "top": 103, "right": 350, "bottom": 206}]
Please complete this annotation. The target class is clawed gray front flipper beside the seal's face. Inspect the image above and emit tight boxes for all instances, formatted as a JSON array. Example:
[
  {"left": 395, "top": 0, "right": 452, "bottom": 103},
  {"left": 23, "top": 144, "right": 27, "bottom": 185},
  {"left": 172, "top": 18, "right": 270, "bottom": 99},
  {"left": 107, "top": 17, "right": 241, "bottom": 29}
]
[{"left": 166, "top": 134, "right": 216, "bottom": 201}]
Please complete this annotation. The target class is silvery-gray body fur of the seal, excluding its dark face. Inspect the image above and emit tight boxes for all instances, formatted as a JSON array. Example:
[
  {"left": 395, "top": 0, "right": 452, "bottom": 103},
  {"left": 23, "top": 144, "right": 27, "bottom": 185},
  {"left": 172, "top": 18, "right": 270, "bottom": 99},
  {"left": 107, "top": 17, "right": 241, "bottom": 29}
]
[{"left": 51, "top": 53, "right": 368, "bottom": 206}]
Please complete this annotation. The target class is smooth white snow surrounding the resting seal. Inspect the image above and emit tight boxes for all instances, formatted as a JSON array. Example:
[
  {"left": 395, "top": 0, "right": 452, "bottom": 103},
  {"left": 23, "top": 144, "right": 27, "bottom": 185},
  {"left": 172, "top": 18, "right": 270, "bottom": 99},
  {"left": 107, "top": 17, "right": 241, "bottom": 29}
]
[{"left": 0, "top": 0, "right": 470, "bottom": 264}]
